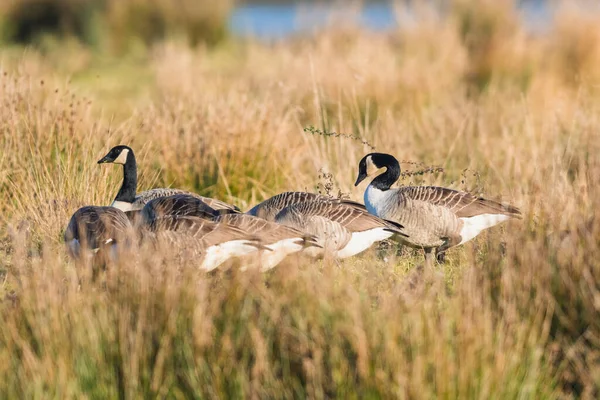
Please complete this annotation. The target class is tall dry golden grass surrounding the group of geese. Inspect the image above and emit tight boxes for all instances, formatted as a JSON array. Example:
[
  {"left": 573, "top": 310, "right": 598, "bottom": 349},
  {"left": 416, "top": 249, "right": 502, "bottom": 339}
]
[{"left": 0, "top": 2, "right": 600, "bottom": 399}]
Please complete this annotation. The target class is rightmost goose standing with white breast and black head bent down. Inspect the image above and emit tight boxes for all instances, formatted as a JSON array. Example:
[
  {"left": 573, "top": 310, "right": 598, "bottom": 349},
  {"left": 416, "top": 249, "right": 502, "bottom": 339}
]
[{"left": 354, "top": 153, "right": 521, "bottom": 264}]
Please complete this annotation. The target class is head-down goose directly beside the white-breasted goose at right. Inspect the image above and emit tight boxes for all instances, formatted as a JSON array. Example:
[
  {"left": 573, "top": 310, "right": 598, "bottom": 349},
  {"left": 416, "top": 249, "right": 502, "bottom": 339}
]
[{"left": 275, "top": 200, "right": 405, "bottom": 258}]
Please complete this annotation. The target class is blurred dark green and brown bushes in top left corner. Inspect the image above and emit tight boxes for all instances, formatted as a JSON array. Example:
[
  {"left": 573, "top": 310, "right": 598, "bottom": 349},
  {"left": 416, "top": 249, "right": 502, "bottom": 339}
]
[{"left": 0, "top": 0, "right": 233, "bottom": 52}]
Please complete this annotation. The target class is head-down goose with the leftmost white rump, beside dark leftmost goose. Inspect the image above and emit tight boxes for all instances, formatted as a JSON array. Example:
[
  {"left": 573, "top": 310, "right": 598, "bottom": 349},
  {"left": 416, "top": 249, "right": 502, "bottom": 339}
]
[{"left": 142, "top": 209, "right": 266, "bottom": 271}]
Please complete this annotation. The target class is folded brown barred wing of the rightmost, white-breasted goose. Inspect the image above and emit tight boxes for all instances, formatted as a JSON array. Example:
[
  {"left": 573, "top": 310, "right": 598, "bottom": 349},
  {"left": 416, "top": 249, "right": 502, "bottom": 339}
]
[{"left": 400, "top": 186, "right": 521, "bottom": 218}]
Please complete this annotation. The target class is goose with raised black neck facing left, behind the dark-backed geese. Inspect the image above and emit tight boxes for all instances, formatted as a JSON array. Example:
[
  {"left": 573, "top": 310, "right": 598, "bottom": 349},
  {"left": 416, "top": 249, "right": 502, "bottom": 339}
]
[{"left": 98, "top": 145, "right": 236, "bottom": 211}]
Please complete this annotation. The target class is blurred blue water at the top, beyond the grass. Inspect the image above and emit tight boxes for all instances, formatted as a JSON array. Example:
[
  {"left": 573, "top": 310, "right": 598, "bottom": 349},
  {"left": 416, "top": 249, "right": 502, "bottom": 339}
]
[{"left": 229, "top": 0, "right": 552, "bottom": 40}]
